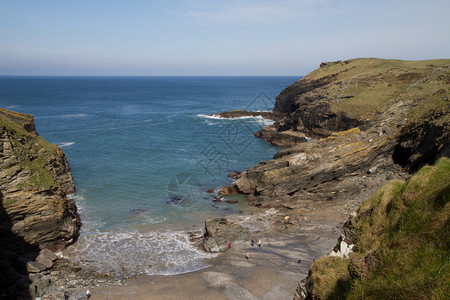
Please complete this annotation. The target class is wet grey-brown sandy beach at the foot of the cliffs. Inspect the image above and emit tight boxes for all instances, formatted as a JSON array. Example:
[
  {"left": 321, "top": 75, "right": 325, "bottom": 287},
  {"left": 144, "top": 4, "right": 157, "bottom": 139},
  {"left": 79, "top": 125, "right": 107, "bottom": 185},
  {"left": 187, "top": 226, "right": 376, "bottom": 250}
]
[{"left": 63, "top": 202, "right": 348, "bottom": 300}]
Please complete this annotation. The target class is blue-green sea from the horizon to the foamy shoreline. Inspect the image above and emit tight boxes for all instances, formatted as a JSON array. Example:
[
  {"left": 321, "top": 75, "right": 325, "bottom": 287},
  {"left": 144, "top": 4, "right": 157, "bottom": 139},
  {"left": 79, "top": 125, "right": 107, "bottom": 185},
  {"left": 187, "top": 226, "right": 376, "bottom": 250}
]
[{"left": 0, "top": 76, "right": 301, "bottom": 278}]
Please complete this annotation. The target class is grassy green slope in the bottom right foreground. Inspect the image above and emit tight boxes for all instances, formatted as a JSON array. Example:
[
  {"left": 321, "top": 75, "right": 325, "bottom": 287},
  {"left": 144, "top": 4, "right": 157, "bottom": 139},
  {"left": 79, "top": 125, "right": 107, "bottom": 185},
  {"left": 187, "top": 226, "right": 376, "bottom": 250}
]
[{"left": 311, "top": 158, "right": 450, "bottom": 299}]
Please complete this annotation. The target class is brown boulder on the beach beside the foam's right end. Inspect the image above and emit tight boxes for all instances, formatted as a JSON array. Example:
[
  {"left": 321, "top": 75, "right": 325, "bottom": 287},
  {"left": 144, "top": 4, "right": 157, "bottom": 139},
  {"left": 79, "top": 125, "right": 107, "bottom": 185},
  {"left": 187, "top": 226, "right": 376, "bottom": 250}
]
[{"left": 203, "top": 217, "right": 249, "bottom": 252}]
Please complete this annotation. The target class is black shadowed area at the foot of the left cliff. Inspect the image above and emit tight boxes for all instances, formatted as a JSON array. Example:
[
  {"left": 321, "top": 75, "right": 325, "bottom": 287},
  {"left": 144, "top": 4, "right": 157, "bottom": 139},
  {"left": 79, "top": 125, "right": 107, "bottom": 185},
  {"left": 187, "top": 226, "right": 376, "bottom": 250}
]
[{"left": 0, "top": 191, "right": 39, "bottom": 300}]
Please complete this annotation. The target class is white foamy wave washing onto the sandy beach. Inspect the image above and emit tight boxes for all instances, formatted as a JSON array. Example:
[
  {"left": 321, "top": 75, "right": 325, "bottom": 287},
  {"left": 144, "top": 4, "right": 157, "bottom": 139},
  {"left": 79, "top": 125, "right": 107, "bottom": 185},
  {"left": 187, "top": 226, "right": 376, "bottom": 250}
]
[{"left": 64, "top": 231, "right": 216, "bottom": 278}]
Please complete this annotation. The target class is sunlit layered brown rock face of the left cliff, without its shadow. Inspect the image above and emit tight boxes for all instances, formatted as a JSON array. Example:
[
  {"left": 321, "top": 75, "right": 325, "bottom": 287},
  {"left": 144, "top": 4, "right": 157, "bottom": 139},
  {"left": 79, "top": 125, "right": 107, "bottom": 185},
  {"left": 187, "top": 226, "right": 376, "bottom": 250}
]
[{"left": 0, "top": 123, "right": 80, "bottom": 250}]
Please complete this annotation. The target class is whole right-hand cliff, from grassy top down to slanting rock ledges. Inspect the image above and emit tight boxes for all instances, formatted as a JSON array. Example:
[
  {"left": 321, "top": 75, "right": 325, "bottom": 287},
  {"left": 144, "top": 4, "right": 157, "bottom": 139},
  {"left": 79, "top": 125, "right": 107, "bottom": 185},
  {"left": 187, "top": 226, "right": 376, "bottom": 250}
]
[{"left": 235, "top": 59, "right": 450, "bottom": 212}]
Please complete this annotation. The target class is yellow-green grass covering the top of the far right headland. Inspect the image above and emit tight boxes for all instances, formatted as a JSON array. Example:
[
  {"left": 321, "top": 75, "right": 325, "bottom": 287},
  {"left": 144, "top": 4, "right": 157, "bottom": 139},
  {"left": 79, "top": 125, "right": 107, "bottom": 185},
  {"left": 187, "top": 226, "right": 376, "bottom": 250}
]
[{"left": 305, "top": 58, "right": 450, "bottom": 121}]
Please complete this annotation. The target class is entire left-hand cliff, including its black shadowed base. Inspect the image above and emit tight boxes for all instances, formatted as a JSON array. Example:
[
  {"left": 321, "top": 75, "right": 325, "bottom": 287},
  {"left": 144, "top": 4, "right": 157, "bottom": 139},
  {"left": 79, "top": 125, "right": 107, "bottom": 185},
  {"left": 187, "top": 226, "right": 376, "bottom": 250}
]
[{"left": 0, "top": 109, "right": 80, "bottom": 298}]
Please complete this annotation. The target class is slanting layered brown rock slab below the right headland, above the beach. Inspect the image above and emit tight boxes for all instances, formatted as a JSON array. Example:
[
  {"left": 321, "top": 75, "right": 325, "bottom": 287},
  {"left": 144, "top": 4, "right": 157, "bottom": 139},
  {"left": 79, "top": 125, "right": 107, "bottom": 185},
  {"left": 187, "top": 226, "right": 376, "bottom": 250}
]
[{"left": 235, "top": 128, "right": 395, "bottom": 207}]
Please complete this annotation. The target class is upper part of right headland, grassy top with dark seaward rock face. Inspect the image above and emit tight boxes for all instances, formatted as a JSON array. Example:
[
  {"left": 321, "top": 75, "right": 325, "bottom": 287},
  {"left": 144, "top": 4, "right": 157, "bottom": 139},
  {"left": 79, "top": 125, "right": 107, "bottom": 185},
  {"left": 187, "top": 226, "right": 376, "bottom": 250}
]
[{"left": 274, "top": 58, "right": 450, "bottom": 136}]
